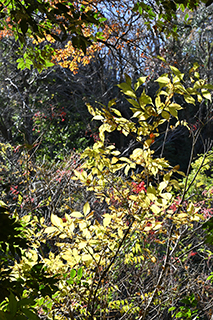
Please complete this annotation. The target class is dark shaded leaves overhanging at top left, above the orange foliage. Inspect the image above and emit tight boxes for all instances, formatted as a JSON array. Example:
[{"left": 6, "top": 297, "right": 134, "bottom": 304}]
[{"left": 0, "top": 0, "right": 105, "bottom": 50}]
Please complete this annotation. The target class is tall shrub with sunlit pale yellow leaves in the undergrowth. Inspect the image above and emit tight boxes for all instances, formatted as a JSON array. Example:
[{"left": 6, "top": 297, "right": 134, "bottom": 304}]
[{"left": 7, "top": 67, "right": 213, "bottom": 319}]
